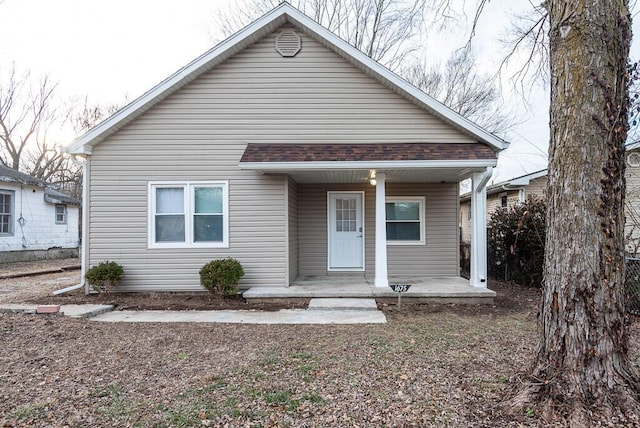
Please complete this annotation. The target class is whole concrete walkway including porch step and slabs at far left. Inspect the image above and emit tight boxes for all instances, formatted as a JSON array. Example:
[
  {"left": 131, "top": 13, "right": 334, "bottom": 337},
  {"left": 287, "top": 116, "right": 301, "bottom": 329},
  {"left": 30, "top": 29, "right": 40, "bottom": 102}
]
[{"left": 0, "top": 299, "right": 387, "bottom": 324}]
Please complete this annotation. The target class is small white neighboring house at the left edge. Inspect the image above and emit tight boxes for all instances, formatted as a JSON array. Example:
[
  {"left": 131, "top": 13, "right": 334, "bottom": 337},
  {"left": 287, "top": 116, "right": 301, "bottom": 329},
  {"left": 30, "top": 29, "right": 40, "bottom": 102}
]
[{"left": 0, "top": 165, "right": 81, "bottom": 262}]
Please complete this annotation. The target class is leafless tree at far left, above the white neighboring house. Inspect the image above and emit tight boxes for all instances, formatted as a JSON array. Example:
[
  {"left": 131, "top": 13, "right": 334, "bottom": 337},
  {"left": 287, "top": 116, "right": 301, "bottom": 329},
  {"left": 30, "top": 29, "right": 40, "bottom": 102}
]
[{"left": 0, "top": 66, "right": 57, "bottom": 170}]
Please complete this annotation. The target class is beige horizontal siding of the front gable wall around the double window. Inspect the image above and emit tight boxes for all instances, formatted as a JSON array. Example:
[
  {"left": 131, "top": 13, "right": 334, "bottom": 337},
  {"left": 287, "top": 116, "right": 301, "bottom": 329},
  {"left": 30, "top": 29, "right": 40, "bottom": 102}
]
[{"left": 88, "top": 24, "right": 474, "bottom": 291}]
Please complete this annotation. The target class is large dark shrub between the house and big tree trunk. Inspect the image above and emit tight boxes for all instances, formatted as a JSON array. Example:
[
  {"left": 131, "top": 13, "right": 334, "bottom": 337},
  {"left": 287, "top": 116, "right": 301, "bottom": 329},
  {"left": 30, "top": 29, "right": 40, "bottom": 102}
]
[{"left": 487, "top": 198, "right": 547, "bottom": 287}]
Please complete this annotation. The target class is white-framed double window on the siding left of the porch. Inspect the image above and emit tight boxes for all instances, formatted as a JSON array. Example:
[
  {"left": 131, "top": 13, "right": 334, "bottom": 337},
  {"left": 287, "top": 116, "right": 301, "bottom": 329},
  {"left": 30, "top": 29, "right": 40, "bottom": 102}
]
[{"left": 149, "top": 182, "right": 229, "bottom": 248}]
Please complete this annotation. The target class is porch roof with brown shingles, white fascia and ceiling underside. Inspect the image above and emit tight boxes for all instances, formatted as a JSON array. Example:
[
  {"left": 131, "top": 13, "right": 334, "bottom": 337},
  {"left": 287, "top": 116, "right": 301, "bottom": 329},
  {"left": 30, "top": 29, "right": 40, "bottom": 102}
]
[{"left": 239, "top": 143, "right": 497, "bottom": 183}]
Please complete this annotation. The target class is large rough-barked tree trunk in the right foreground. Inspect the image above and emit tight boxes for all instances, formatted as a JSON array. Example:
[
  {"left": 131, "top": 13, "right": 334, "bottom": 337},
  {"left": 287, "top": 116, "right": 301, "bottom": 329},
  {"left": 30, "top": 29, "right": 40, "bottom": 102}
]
[{"left": 515, "top": 0, "right": 640, "bottom": 426}]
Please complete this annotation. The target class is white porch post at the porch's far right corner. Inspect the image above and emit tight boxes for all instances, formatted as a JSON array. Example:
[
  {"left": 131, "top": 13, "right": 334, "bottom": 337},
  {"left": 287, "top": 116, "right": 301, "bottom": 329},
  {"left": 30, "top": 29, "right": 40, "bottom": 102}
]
[{"left": 469, "top": 168, "right": 492, "bottom": 288}]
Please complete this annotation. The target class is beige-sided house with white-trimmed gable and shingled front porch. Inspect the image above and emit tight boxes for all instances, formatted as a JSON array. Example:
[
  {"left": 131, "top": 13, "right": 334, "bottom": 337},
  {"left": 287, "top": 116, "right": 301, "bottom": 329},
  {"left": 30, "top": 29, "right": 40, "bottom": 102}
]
[{"left": 68, "top": 3, "right": 507, "bottom": 291}]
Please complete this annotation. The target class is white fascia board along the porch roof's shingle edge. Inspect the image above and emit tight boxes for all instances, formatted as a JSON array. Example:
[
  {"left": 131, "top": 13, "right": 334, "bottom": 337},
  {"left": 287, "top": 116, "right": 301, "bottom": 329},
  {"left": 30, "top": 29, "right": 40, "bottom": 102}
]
[{"left": 238, "top": 159, "right": 497, "bottom": 172}]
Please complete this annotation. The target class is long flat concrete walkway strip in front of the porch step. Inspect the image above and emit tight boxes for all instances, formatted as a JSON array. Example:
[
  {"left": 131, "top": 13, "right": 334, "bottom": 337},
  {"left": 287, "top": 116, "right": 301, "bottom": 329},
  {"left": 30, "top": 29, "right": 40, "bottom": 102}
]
[{"left": 90, "top": 309, "right": 387, "bottom": 324}]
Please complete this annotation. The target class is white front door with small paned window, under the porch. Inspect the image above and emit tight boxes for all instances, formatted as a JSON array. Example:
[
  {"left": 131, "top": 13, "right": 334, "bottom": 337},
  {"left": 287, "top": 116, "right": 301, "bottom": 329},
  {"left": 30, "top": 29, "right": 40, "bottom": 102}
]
[{"left": 328, "top": 192, "right": 364, "bottom": 271}]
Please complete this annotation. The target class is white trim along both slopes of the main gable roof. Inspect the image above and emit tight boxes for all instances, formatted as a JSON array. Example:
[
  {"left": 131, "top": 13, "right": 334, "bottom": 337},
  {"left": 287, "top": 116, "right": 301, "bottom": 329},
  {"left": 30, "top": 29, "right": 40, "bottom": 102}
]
[{"left": 64, "top": 2, "right": 508, "bottom": 154}]
